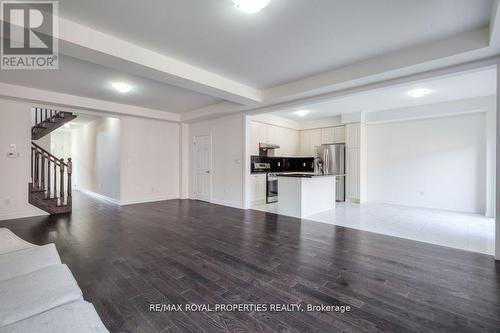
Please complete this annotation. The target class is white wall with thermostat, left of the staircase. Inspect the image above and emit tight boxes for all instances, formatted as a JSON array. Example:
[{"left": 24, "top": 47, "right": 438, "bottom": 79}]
[{"left": 0, "top": 99, "right": 47, "bottom": 220}]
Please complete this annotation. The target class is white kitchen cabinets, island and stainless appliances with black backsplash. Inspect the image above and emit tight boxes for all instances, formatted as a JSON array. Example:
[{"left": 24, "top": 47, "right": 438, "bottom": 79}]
[{"left": 250, "top": 116, "right": 346, "bottom": 218}]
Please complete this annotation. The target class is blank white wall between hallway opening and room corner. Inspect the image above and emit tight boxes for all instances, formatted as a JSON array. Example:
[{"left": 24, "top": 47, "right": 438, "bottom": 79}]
[{"left": 120, "top": 117, "right": 180, "bottom": 204}]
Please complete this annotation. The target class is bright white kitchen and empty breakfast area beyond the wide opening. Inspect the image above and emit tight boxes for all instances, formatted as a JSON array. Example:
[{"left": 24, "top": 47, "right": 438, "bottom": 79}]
[{"left": 244, "top": 70, "right": 496, "bottom": 254}]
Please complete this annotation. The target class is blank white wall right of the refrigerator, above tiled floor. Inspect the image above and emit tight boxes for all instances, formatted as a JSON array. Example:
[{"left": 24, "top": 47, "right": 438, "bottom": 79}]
[{"left": 367, "top": 113, "right": 486, "bottom": 214}]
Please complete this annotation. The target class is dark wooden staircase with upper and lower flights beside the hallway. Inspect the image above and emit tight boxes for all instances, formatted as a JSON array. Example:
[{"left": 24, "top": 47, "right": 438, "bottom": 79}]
[{"left": 28, "top": 108, "right": 76, "bottom": 214}]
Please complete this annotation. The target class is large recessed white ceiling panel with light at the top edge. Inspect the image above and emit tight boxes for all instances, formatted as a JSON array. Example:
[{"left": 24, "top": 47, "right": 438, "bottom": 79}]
[{"left": 59, "top": 0, "right": 493, "bottom": 89}]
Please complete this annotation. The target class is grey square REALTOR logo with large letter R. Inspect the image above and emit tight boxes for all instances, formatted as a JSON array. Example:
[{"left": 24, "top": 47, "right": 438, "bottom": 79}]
[{"left": 1, "top": 1, "right": 59, "bottom": 69}]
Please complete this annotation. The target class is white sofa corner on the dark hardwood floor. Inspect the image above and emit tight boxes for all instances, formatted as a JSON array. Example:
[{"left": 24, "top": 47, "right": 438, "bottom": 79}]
[{"left": 0, "top": 228, "right": 108, "bottom": 333}]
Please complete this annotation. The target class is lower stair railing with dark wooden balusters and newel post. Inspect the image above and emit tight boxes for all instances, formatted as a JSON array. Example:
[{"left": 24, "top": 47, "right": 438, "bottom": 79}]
[{"left": 31, "top": 142, "right": 73, "bottom": 205}]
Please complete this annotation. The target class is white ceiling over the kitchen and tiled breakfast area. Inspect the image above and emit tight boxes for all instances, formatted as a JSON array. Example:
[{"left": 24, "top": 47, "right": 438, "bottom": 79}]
[{"left": 271, "top": 69, "right": 496, "bottom": 121}]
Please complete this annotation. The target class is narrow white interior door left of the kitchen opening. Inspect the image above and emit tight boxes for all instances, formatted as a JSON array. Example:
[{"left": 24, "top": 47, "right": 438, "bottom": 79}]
[{"left": 193, "top": 135, "right": 212, "bottom": 202}]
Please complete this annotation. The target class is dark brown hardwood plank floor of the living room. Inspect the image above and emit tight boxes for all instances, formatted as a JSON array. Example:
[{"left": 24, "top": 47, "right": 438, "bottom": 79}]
[{"left": 0, "top": 193, "right": 500, "bottom": 333}]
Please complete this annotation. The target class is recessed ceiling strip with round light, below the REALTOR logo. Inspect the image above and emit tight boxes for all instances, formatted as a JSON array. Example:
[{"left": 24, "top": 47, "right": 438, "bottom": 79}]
[{"left": 0, "top": 55, "right": 220, "bottom": 113}]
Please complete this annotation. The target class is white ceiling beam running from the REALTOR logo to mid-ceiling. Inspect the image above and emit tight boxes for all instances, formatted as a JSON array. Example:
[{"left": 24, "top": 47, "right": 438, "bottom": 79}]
[{"left": 59, "top": 17, "right": 261, "bottom": 104}]
